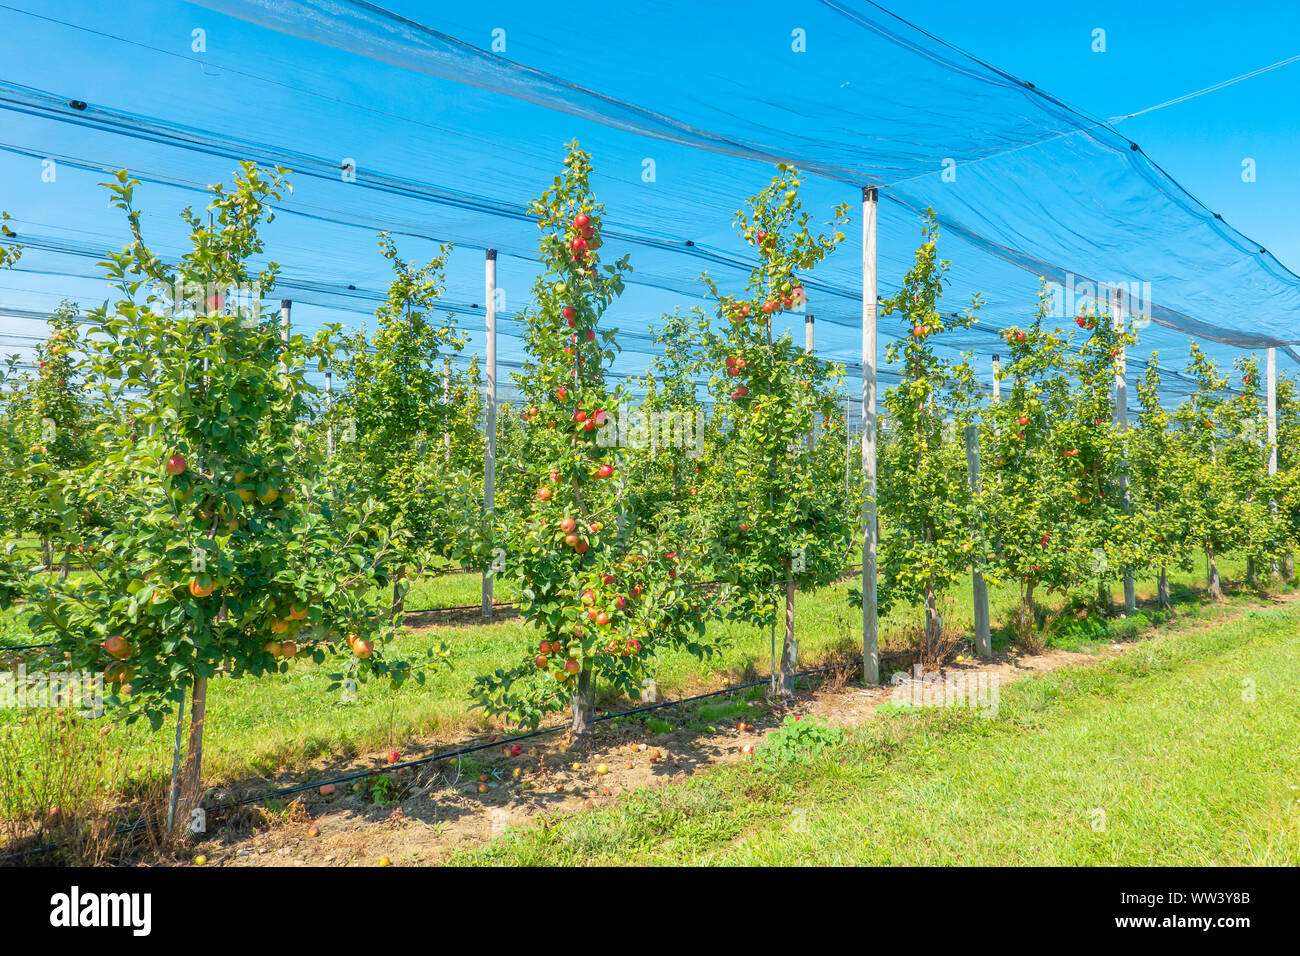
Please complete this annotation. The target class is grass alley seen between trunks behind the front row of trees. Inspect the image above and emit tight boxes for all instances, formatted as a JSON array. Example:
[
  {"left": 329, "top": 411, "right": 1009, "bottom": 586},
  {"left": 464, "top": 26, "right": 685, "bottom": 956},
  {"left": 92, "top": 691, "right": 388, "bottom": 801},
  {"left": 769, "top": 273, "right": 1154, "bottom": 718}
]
[{"left": 0, "top": 562, "right": 1279, "bottom": 822}]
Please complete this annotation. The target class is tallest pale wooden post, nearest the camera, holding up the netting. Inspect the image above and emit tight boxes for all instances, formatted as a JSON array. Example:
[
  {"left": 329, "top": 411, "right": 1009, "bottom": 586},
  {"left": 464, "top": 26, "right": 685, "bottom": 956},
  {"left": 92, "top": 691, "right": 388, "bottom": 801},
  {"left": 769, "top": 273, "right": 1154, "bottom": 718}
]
[{"left": 862, "top": 186, "right": 880, "bottom": 685}]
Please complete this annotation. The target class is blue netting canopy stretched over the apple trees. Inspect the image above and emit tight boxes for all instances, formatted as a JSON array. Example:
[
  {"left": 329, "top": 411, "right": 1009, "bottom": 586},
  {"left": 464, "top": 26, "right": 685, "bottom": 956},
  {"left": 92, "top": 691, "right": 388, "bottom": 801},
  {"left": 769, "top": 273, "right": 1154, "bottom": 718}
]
[{"left": 0, "top": 0, "right": 1300, "bottom": 411}]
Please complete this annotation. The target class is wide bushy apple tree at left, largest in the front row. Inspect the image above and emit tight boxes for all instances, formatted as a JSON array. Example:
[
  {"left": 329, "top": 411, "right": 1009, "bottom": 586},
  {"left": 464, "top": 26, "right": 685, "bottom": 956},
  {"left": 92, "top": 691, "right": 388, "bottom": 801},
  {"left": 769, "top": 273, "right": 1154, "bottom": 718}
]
[{"left": 2, "top": 163, "right": 444, "bottom": 821}]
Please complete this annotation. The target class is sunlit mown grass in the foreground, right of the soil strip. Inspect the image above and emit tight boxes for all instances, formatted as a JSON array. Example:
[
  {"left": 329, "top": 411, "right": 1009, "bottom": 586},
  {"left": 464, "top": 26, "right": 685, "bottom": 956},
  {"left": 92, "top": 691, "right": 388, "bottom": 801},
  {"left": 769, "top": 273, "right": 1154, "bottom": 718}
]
[{"left": 452, "top": 595, "right": 1300, "bottom": 866}]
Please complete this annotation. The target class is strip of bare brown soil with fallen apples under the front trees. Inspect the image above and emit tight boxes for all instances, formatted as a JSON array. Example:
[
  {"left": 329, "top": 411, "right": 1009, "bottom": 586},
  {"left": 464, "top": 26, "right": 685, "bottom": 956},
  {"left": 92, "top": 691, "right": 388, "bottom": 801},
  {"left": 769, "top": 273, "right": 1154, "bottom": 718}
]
[{"left": 192, "top": 594, "right": 1300, "bottom": 866}]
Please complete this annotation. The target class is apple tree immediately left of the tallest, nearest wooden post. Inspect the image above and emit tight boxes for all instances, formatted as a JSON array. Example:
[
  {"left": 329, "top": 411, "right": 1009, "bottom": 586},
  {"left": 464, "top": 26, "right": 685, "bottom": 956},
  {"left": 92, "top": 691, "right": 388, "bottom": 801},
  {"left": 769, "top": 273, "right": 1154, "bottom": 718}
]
[{"left": 705, "top": 164, "right": 855, "bottom": 695}]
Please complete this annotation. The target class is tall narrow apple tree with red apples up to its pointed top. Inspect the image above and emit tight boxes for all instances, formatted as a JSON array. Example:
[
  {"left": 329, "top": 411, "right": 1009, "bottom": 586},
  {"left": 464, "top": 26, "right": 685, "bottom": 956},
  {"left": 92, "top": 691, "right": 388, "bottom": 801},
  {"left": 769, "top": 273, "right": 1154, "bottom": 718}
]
[{"left": 475, "top": 143, "right": 711, "bottom": 739}]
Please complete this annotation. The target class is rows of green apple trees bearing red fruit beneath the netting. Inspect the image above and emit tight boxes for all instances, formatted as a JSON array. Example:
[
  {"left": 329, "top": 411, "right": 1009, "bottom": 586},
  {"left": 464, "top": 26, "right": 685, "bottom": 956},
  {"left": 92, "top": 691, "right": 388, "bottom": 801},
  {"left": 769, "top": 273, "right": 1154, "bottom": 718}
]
[{"left": 0, "top": 144, "right": 1300, "bottom": 837}]
